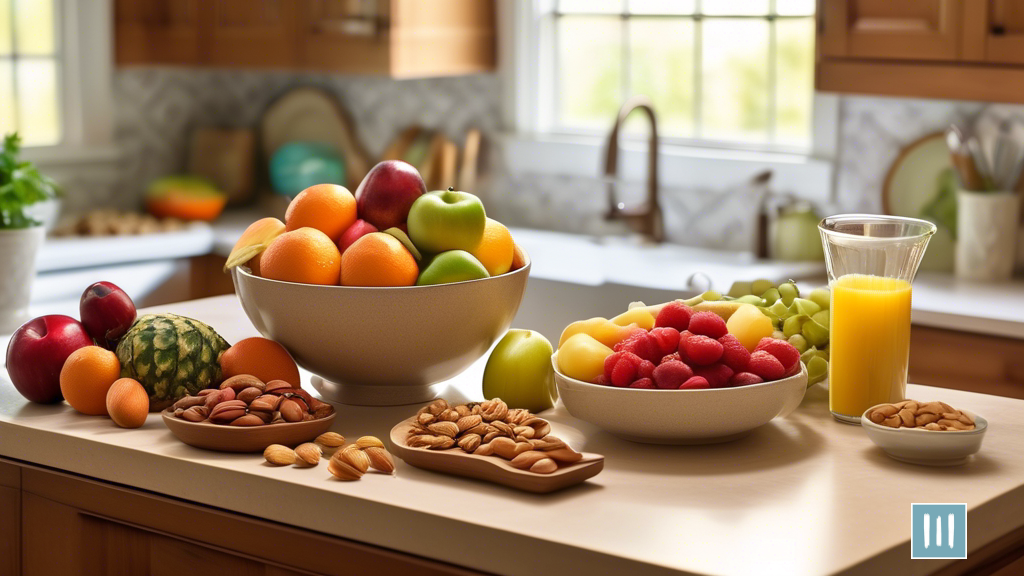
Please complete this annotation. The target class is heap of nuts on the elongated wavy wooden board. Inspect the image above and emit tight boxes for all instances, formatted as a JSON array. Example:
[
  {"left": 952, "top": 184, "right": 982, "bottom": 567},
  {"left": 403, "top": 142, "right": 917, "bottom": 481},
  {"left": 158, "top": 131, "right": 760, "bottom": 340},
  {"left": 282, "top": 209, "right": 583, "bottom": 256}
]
[{"left": 407, "top": 398, "right": 583, "bottom": 474}]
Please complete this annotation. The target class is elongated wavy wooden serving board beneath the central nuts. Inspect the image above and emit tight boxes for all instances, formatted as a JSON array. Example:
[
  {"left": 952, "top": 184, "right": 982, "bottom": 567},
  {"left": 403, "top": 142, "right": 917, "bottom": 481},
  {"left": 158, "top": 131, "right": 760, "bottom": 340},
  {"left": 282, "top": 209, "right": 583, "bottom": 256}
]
[{"left": 390, "top": 416, "right": 604, "bottom": 494}]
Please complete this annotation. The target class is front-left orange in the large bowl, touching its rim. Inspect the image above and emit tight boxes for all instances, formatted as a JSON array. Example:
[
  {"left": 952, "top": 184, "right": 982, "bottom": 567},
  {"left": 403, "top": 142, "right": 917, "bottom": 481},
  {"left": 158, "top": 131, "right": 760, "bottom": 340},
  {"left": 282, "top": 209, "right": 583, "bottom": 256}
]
[{"left": 259, "top": 228, "right": 341, "bottom": 285}]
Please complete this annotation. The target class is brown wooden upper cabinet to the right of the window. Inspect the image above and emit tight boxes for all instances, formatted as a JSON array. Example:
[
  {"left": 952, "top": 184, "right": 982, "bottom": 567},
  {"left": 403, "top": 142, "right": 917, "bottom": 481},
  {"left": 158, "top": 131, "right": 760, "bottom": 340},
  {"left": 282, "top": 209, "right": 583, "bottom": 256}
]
[{"left": 815, "top": 0, "right": 1024, "bottom": 102}]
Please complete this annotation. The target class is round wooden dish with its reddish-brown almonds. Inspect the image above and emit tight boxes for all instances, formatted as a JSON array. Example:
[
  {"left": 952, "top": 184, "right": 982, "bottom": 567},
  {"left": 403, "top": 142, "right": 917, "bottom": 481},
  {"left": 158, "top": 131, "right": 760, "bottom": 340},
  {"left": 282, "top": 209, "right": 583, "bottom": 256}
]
[{"left": 161, "top": 374, "right": 335, "bottom": 452}]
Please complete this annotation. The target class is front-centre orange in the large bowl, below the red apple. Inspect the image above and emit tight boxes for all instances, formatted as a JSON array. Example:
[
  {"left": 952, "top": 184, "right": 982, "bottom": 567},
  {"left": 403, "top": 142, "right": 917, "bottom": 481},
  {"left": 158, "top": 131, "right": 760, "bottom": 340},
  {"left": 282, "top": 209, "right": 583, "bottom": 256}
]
[{"left": 342, "top": 232, "right": 420, "bottom": 286}]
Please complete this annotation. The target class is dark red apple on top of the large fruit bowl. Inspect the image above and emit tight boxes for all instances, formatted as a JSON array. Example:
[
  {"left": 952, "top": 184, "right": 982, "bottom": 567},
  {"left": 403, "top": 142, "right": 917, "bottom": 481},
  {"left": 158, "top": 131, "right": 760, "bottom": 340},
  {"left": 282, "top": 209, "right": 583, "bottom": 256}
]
[{"left": 355, "top": 160, "right": 427, "bottom": 230}]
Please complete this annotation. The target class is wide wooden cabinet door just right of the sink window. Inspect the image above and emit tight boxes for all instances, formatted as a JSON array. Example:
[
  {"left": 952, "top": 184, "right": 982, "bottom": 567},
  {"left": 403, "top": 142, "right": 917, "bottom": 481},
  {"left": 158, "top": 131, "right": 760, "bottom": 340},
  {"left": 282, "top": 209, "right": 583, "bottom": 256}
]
[{"left": 818, "top": 0, "right": 963, "bottom": 60}]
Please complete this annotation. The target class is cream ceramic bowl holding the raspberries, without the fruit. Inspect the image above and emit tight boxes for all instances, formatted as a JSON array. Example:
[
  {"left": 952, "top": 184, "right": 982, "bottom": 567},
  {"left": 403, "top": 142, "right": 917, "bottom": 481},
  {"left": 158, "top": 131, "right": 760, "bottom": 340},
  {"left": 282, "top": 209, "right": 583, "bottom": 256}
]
[{"left": 551, "top": 352, "right": 807, "bottom": 444}]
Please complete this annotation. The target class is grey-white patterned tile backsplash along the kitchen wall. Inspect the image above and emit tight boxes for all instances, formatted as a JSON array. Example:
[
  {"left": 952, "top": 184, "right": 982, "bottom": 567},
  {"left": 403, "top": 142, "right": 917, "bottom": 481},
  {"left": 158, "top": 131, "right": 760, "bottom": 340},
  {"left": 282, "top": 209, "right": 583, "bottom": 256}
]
[{"left": 56, "top": 68, "right": 1024, "bottom": 247}]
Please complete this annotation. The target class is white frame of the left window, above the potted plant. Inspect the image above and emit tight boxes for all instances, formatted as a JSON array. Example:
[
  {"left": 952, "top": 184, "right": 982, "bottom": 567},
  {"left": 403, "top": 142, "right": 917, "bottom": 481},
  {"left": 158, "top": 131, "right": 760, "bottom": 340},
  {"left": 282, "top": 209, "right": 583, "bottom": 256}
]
[{"left": 17, "top": 0, "right": 119, "bottom": 167}]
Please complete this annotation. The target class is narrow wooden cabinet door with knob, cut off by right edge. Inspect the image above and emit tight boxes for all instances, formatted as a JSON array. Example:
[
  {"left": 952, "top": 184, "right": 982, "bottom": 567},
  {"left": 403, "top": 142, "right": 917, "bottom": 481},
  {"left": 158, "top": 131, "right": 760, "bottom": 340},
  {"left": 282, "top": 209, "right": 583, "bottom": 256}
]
[{"left": 964, "top": 0, "right": 1024, "bottom": 64}]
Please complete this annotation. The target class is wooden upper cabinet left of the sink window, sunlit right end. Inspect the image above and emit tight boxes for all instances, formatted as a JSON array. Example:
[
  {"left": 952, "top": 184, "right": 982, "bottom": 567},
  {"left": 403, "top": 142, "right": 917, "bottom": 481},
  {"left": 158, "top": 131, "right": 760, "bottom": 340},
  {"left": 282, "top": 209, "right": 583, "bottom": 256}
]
[{"left": 116, "top": 0, "right": 496, "bottom": 78}]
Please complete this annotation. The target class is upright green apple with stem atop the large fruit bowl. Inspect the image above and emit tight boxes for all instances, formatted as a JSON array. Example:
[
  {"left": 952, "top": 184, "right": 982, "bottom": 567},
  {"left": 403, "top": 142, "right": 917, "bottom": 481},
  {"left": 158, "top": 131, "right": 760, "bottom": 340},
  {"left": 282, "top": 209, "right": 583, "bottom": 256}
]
[{"left": 409, "top": 188, "right": 487, "bottom": 253}]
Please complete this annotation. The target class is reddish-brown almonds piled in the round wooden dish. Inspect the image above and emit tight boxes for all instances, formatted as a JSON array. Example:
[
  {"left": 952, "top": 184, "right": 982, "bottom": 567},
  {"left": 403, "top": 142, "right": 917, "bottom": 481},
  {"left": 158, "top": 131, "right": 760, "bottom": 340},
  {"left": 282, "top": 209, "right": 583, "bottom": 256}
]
[{"left": 172, "top": 374, "right": 334, "bottom": 426}]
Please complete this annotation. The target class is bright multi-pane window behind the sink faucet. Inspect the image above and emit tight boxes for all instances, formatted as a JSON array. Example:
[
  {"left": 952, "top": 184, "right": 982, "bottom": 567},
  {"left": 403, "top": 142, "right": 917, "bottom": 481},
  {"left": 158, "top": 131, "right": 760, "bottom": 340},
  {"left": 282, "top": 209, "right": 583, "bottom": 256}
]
[{"left": 536, "top": 0, "right": 815, "bottom": 152}]
